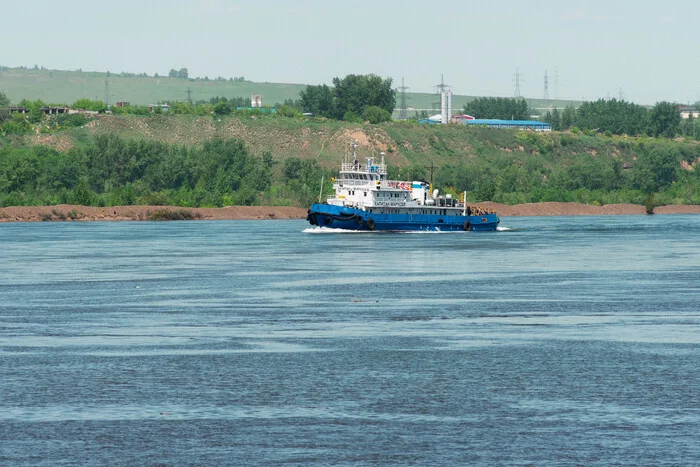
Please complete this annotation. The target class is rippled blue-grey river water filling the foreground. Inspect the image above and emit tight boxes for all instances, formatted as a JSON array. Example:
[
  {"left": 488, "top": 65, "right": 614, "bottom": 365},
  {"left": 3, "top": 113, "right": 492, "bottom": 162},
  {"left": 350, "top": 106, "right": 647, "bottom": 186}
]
[{"left": 0, "top": 216, "right": 700, "bottom": 466}]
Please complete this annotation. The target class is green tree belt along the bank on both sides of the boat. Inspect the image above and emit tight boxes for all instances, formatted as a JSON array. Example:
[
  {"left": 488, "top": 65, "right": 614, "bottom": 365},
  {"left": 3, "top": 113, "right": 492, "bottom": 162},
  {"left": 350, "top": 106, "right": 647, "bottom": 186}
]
[{"left": 0, "top": 129, "right": 700, "bottom": 207}]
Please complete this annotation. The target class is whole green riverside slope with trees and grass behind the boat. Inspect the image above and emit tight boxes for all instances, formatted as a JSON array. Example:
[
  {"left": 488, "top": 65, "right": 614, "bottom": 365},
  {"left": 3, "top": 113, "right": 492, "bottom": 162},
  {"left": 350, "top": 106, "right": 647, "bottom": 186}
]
[{"left": 0, "top": 111, "right": 700, "bottom": 207}]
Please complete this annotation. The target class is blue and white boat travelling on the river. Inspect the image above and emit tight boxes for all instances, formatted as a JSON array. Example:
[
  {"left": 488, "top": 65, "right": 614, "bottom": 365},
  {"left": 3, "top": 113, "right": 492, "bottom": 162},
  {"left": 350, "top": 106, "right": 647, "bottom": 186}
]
[{"left": 306, "top": 144, "right": 500, "bottom": 232}]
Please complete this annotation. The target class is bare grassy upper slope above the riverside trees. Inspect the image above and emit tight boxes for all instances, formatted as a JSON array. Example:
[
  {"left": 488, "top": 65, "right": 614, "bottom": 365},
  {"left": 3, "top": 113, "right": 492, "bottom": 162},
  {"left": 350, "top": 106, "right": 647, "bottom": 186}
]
[{"left": 21, "top": 115, "right": 700, "bottom": 168}]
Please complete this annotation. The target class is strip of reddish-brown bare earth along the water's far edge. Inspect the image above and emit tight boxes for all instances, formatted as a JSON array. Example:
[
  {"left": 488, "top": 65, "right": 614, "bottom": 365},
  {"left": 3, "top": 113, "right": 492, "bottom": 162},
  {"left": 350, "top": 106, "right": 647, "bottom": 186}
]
[{"left": 0, "top": 202, "right": 700, "bottom": 222}]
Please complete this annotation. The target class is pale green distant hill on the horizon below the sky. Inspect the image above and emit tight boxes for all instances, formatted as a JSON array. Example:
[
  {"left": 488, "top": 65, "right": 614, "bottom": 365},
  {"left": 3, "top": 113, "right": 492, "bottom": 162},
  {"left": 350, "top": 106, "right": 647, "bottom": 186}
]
[{"left": 0, "top": 67, "right": 580, "bottom": 114}]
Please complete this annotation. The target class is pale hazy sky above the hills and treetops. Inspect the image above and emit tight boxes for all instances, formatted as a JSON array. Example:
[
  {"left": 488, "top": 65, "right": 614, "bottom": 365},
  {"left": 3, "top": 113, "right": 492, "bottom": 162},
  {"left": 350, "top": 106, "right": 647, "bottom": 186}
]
[{"left": 0, "top": 0, "right": 700, "bottom": 104}]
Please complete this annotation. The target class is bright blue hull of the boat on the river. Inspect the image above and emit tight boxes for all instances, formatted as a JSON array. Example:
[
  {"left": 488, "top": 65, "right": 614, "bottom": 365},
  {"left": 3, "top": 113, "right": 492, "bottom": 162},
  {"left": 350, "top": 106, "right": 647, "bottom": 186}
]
[{"left": 306, "top": 204, "right": 500, "bottom": 232}]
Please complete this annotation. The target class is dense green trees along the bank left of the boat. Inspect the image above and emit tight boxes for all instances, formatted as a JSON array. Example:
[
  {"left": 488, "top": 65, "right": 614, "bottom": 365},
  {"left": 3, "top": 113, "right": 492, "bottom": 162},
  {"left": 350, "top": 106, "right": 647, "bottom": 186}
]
[{"left": 0, "top": 135, "right": 330, "bottom": 207}]
